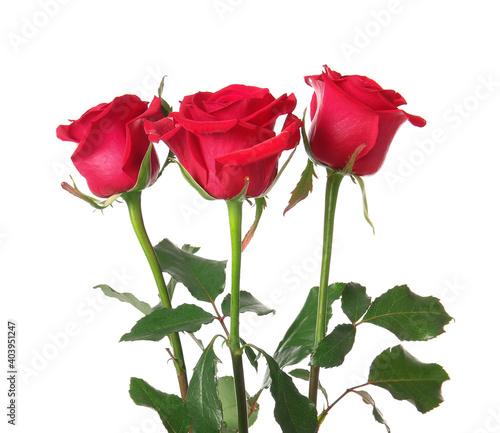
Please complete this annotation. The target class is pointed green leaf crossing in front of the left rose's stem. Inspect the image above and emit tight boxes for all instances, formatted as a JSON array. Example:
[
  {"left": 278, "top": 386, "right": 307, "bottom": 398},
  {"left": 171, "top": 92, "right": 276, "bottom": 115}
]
[{"left": 120, "top": 304, "right": 215, "bottom": 341}]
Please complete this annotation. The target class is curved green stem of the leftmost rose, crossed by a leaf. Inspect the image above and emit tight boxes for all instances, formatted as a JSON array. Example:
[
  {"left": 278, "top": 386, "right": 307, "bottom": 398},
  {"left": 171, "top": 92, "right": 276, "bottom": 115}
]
[{"left": 123, "top": 191, "right": 188, "bottom": 400}]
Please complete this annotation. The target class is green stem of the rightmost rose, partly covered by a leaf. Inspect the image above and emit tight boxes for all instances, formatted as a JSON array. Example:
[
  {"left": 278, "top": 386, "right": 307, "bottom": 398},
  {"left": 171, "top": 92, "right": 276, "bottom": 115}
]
[{"left": 309, "top": 169, "right": 344, "bottom": 405}]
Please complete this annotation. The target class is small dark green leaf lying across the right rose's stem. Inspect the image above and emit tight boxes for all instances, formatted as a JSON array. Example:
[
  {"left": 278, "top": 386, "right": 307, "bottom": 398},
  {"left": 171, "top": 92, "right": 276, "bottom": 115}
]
[{"left": 311, "top": 323, "right": 356, "bottom": 368}]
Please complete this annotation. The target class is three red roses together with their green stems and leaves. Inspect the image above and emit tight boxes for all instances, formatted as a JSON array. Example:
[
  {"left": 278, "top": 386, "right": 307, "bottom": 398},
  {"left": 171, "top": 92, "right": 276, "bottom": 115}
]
[{"left": 57, "top": 67, "right": 451, "bottom": 433}]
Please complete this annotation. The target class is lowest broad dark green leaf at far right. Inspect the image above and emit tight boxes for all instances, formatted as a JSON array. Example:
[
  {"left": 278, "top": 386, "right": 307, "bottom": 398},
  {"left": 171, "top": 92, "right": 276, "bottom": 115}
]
[{"left": 368, "top": 346, "right": 450, "bottom": 413}]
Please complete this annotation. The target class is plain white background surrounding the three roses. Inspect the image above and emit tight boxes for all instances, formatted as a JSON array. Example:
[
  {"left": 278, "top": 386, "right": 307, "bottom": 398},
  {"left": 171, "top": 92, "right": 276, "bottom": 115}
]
[{"left": 0, "top": 0, "right": 500, "bottom": 433}]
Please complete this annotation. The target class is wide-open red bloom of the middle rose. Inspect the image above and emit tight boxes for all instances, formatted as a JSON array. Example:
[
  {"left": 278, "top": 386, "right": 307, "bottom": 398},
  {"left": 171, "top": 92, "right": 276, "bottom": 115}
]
[{"left": 145, "top": 84, "right": 302, "bottom": 200}]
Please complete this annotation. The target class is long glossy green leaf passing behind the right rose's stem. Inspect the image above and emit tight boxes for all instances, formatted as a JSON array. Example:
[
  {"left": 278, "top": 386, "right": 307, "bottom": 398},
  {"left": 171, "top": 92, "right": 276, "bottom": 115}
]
[{"left": 274, "top": 283, "right": 345, "bottom": 367}]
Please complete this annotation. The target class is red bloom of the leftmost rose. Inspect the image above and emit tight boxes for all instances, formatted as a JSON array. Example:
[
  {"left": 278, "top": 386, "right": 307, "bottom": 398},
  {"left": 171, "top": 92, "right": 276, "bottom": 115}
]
[{"left": 57, "top": 95, "right": 163, "bottom": 198}]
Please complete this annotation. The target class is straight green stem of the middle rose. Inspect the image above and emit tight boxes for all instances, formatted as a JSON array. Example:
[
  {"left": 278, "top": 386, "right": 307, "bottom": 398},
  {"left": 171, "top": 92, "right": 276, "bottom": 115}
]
[{"left": 227, "top": 200, "right": 248, "bottom": 433}]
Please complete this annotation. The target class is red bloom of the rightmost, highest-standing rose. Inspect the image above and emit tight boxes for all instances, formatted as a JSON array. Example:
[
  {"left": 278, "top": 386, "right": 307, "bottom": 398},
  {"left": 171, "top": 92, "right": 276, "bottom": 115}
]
[{"left": 305, "top": 66, "right": 426, "bottom": 176}]
